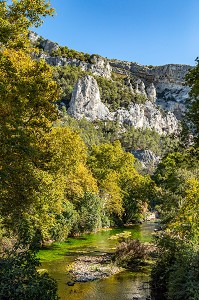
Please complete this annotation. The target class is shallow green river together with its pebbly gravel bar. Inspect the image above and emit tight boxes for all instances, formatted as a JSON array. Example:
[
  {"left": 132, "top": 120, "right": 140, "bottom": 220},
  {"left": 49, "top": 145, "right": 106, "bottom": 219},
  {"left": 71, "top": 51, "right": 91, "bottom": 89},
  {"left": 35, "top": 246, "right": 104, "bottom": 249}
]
[{"left": 38, "top": 222, "right": 156, "bottom": 300}]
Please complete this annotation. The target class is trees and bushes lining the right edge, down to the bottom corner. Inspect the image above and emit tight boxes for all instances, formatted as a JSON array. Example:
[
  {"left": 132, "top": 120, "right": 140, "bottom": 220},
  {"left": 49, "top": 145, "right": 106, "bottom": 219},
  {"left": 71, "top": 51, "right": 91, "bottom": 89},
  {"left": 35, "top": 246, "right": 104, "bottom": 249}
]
[{"left": 152, "top": 55, "right": 199, "bottom": 300}]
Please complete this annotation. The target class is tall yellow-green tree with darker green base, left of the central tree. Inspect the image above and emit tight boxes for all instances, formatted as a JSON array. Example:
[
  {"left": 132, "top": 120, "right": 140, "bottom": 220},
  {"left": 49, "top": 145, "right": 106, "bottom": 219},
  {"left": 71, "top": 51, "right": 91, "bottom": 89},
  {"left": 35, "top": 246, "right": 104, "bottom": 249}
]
[{"left": 45, "top": 126, "right": 101, "bottom": 240}]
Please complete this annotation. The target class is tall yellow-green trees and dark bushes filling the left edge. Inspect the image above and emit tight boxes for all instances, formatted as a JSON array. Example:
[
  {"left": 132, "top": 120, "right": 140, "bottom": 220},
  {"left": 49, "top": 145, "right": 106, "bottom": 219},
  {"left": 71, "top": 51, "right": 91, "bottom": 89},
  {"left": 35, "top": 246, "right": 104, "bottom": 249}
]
[{"left": 0, "top": 0, "right": 60, "bottom": 300}]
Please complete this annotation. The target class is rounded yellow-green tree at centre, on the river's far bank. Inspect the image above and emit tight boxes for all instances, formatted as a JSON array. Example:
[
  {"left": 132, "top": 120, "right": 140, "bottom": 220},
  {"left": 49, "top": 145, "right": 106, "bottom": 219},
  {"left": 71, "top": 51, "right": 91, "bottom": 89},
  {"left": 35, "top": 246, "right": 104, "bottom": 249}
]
[{"left": 89, "top": 141, "right": 150, "bottom": 222}]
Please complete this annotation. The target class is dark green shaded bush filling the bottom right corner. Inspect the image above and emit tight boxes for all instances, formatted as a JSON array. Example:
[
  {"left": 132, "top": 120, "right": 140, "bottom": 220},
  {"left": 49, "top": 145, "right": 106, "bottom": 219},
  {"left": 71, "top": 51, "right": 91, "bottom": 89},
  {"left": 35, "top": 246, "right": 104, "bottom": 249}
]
[{"left": 151, "top": 234, "right": 199, "bottom": 300}]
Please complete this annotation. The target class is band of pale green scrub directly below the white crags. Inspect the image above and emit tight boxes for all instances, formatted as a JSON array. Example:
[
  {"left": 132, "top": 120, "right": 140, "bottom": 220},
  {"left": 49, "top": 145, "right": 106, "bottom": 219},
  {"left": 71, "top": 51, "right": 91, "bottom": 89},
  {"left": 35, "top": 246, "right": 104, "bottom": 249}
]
[{"left": 60, "top": 114, "right": 179, "bottom": 162}]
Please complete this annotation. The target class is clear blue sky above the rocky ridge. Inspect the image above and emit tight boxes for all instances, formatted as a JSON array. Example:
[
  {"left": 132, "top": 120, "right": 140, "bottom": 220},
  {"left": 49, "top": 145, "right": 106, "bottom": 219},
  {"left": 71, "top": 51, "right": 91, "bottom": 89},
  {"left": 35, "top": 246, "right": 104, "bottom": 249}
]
[{"left": 35, "top": 0, "right": 199, "bottom": 66}]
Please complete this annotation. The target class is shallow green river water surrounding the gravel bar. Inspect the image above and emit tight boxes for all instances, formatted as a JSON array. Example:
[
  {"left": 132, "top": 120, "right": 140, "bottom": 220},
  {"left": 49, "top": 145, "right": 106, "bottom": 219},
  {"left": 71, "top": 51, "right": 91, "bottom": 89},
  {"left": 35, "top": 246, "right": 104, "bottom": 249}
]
[{"left": 39, "top": 223, "right": 155, "bottom": 300}]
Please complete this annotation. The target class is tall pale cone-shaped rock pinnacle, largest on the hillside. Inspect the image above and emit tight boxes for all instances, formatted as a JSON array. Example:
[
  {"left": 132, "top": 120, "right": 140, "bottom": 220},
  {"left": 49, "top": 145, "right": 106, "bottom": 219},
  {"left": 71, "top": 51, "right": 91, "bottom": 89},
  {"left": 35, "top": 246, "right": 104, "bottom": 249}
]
[{"left": 68, "top": 75, "right": 110, "bottom": 121}]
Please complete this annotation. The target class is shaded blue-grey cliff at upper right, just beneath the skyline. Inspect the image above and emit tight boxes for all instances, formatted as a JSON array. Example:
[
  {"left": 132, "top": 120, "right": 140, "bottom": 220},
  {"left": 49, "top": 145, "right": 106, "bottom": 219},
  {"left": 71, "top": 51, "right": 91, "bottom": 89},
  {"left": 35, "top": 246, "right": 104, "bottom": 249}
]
[{"left": 110, "top": 60, "right": 193, "bottom": 120}]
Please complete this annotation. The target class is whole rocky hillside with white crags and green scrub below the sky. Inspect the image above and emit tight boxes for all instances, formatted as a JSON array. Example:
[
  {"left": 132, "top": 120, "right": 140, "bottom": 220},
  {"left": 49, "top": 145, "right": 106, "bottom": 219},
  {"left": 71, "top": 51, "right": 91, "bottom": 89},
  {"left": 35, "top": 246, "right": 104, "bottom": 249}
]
[{"left": 30, "top": 32, "right": 192, "bottom": 170}]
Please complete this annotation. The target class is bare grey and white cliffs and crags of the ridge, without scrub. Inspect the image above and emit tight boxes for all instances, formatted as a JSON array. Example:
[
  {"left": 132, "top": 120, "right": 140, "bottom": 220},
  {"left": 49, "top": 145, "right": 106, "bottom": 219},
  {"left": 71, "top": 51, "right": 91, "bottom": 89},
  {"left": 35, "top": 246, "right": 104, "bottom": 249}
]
[{"left": 30, "top": 33, "right": 192, "bottom": 134}]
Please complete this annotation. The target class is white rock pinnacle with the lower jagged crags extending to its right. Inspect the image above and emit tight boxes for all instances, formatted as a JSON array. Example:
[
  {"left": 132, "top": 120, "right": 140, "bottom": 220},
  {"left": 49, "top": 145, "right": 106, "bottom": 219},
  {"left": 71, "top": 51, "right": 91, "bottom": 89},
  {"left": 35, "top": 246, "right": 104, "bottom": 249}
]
[{"left": 68, "top": 75, "right": 179, "bottom": 134}]
